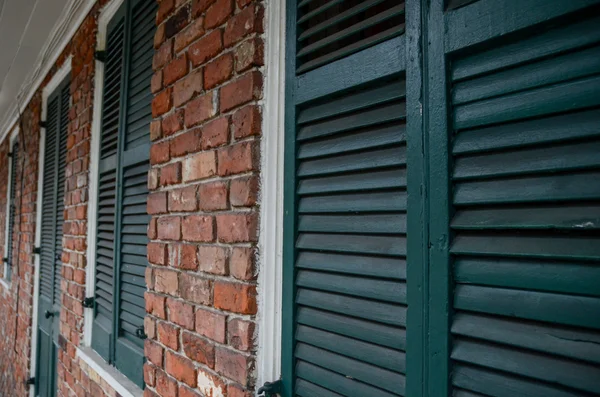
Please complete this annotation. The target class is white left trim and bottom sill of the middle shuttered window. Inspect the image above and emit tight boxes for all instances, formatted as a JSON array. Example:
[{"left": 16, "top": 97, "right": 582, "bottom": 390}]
[{"left": 82, "top": 0, "right": 144, "bottom": 397}]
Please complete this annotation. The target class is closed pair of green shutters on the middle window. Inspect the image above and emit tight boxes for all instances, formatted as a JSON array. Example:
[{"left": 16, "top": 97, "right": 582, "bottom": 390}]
[{"left": 93, "top": 1, "right": 157, "bottom": 386}]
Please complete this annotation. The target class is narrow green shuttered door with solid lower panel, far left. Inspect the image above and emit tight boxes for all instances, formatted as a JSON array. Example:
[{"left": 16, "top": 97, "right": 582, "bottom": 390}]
[{"left": 34, "top": 78, "right": 70, "bottom": 397}]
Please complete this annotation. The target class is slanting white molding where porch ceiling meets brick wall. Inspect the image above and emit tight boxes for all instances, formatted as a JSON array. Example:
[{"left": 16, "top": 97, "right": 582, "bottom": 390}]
[{"left": 0, "top": 0, "right": 96, "bottom": 143}]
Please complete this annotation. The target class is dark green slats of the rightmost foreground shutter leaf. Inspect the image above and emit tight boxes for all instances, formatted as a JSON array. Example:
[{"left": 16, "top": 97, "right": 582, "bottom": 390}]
[{"left": 448, "top": 1, "right": 600, "bottom": 396}]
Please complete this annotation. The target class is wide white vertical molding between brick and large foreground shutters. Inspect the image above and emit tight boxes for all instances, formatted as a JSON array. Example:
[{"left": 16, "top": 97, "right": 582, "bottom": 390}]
[{"left": 257, "top": 0, "right": 286, "bottom": 386}]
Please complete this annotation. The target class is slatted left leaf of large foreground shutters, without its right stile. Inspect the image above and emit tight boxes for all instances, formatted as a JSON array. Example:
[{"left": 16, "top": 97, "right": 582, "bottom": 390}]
[{"left": 283, "top": 0, "right": 407, "bottom": 396}]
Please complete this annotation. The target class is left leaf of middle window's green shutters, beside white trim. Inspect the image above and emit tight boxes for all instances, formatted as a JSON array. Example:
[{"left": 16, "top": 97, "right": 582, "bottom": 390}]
[{"left": 92, "top": 6, "right": 125, "bottom": 362}]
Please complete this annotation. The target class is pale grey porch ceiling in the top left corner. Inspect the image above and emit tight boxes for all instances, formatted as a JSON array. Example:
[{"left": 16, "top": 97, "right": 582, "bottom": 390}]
[{"left": 0, "top": 0, "right": 73, "bottom": 132}]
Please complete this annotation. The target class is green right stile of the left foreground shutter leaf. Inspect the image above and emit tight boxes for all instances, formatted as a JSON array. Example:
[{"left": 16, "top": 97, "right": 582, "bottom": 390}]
[{"left": 405, "top": 0, "right": 429, "bottom": 397}]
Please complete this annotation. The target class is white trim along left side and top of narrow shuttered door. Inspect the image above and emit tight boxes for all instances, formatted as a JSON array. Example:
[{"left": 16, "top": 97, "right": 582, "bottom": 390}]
[{"left": 29, "top": 57, "right": 72, "bottom": 397}]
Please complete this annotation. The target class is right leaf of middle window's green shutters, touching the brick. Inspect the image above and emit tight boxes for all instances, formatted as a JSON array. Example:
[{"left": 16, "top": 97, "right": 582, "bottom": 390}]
[{"left": 115, "top": 1, "right": 157, "bottom": 385}]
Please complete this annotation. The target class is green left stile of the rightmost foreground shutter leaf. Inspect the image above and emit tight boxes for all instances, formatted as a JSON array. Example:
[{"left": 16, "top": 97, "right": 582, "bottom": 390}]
[{"left": 423, "top": 0, "right": 451, "bottom": 397}]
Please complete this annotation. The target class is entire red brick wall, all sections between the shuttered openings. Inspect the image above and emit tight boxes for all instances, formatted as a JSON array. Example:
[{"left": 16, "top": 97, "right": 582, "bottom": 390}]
[{"left": 0, "top": 0, "right": 263, "bottom": 397}]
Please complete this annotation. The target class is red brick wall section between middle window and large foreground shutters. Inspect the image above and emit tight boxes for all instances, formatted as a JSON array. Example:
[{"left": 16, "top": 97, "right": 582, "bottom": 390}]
[{"left": 145, "top": 0, "right": 263, "bottom": 397}]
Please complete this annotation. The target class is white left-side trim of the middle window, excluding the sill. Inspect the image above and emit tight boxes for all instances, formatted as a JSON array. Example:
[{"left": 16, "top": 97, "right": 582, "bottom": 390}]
[{"left": 83, "top": 0, "right": 124, "bottom": 346}]
